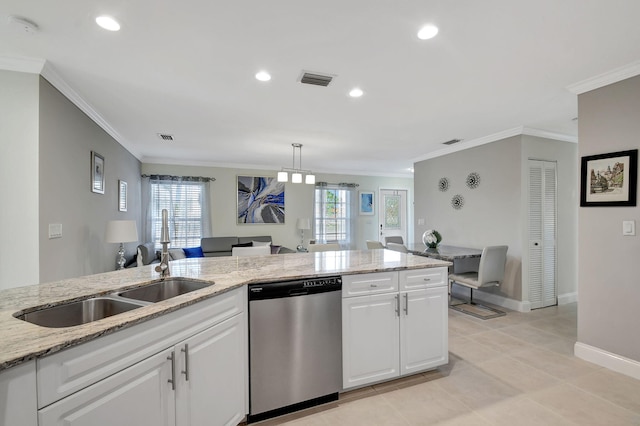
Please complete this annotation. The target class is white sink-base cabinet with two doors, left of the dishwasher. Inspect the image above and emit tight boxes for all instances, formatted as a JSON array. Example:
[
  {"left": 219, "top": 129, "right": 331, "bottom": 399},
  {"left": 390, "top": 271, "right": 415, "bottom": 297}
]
[{"left": 38, "top": 287, "right": 247, "bottom": 426}]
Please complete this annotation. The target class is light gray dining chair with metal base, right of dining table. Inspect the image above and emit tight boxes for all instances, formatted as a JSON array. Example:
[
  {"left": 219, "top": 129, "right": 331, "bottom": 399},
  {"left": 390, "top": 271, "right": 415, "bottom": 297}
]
[{"left": 449, "top": 246, "right": 509, "bottom": 318}]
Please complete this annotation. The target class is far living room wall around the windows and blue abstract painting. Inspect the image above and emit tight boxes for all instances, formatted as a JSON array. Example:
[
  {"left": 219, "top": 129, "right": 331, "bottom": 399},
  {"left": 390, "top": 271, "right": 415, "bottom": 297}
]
[{"left": 142, "top": 163, "right": 413, "bottom": 249}]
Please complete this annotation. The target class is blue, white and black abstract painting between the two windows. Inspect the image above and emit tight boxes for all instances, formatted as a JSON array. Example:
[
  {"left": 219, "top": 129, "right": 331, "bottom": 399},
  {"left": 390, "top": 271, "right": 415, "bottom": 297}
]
[{"left": 237, "top": 176, "right": 284, "bottom": 224}]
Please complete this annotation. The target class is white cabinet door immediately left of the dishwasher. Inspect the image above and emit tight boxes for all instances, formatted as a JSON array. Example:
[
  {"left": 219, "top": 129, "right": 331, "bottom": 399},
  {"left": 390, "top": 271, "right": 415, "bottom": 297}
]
[{"left": 175, "top": 314, "right": 246, "bottom": 426}]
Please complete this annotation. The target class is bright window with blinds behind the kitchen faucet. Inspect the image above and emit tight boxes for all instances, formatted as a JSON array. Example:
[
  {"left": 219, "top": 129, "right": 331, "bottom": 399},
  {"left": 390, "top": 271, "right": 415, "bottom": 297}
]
[{"left": 145, "top": 176, "right": 211, "bottom": 249}]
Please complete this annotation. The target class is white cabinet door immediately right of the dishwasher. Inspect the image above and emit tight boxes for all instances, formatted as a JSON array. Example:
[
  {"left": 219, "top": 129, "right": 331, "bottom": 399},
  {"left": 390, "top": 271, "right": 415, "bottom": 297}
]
[{"left": 342, "top": 292, "right": 400, "bottom": 389}]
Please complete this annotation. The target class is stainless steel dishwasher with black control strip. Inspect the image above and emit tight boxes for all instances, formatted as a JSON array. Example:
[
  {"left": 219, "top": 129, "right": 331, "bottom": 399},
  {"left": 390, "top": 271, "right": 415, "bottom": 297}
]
[{"left": 247, "top": 276, "right": 342, "bottom": 423}]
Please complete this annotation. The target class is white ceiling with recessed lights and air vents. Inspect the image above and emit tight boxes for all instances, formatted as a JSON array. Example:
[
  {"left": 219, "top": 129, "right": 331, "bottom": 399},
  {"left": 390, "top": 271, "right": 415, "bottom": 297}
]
[{"left": 0, "top": 0, "right": 640, "bottom": 176}]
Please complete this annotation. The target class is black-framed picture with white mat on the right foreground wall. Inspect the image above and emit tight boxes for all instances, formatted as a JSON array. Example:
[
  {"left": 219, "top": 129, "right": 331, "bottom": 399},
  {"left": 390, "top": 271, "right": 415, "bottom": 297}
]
[{"left": 580, "top": 149, "right": 638, "bottom": 207}]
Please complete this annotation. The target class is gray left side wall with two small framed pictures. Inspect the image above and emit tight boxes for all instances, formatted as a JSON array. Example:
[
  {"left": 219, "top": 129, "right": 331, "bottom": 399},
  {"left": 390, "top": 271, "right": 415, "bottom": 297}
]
[{"left": 39, "top": 78, "right": 141, "bottom": 282}]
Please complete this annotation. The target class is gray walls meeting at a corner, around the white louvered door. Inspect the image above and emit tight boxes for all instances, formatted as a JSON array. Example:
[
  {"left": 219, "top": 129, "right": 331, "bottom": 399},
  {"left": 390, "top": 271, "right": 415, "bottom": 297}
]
[{"left": 414, "top": 135, "right": 578, "bottom": 309}]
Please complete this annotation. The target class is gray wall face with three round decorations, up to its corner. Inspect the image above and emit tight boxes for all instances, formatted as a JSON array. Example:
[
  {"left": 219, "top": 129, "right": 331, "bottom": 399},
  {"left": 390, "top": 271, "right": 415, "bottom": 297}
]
[{"left": 414, "top": 136, "right": 522, "bottom": 300}]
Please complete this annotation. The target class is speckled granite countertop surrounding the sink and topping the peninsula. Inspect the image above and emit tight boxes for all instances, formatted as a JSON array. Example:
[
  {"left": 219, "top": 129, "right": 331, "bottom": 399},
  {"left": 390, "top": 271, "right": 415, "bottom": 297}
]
[{"left": 0, "top": 250, "right": 450, "bottom": 371}]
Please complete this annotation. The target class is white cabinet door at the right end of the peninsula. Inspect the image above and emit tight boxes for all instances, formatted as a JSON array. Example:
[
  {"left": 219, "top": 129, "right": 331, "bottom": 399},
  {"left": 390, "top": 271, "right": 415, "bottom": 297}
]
[{"left": 400, "top": 287, "right": 449, "bottom": 375}]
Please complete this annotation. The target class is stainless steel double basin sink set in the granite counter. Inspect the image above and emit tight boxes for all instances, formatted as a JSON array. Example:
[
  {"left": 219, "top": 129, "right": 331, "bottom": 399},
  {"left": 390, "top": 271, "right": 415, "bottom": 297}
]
[{"left": 16, "top": 277, "right": 213, "bottom": 328}]
